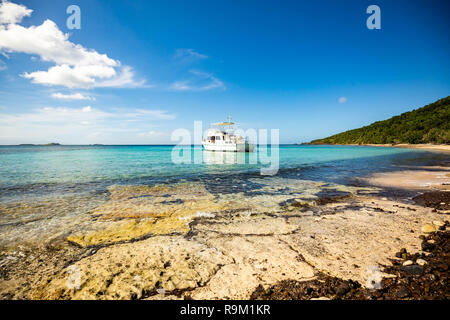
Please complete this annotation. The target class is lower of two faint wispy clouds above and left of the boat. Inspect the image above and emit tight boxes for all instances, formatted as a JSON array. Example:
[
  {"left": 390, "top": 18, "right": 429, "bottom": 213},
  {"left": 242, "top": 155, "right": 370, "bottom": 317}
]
[{"left": 170, "top": 70, "right": 226, "bottom": 91}]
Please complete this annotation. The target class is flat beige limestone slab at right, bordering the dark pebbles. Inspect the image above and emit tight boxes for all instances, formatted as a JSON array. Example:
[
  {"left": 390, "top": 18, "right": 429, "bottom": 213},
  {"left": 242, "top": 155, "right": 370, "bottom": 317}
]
[{"left": 280, "top": 197, "right": 437, "bottom": 285}]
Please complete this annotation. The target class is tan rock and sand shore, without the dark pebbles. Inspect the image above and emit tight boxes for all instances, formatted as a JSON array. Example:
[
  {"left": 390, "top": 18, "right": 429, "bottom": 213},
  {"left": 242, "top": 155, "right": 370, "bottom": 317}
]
[{"left": 0, "top": 158, "right": 450, "bottom": 299}]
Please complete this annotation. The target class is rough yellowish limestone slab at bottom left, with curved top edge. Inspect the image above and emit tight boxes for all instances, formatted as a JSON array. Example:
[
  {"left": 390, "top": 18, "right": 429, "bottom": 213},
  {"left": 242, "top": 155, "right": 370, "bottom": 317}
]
[{"left": 31, "top": 236, "right": 232, "bottom": 299}]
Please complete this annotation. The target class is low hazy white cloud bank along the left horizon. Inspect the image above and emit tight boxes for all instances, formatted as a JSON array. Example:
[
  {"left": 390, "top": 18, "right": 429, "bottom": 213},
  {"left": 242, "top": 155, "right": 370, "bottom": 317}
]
[{"left": 0, "top": 105, "right": 175, "bottom": 144}]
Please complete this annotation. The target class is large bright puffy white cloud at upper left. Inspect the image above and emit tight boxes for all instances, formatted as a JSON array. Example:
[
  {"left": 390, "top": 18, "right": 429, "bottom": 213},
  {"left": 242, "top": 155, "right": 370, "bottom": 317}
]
[{"left": 0, "top": 1, "right": 144, "bottom": 88}]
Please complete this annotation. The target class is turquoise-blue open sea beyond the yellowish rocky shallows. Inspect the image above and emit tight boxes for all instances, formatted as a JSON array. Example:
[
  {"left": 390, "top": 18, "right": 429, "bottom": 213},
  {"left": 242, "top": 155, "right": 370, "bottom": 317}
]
[{"left": 0, "top": 145, "right": 445, "bottom": 201}]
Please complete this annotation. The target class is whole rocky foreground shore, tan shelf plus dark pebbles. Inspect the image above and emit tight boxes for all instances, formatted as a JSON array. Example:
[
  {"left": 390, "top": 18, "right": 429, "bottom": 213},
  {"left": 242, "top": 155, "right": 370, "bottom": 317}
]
[{"left": 0, "top": 166, "right": 449, "bottom": 299}]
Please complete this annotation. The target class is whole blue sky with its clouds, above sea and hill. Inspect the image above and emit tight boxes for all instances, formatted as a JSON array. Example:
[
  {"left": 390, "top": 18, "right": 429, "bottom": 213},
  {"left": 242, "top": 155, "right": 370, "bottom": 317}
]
[{"left": 0, "top": 0, "right": 450, "bottom": 144}]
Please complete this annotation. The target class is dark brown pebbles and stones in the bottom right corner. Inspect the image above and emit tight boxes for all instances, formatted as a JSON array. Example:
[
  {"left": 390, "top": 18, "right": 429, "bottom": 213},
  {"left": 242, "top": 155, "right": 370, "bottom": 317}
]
[{"left": 250, "top": 229, "right": 450, "bottom": 300}]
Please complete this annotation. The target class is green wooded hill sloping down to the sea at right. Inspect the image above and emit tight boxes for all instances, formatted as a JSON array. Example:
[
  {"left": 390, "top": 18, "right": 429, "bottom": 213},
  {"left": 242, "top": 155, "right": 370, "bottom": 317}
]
[{"left": 311, "top": 96, "right": 450, "bottom": 144}]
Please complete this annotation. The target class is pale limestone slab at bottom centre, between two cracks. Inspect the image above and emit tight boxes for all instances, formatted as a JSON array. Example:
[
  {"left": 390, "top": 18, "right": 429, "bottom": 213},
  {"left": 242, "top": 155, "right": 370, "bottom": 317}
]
[{"left": 189, "top": 235, "right": 314, "bottom": 299}]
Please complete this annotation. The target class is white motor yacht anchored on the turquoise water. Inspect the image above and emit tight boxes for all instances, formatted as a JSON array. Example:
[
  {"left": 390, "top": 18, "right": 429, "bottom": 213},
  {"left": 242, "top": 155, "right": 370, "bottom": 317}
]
[{"left": 202, "top": 117, "right": 255, "bottom": 152}]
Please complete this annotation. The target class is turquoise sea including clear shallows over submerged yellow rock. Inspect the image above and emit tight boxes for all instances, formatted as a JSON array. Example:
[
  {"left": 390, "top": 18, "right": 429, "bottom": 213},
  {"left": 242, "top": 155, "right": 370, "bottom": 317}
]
[{"left": 0, "top": 146, "right": 446, "bottom": 247}]
